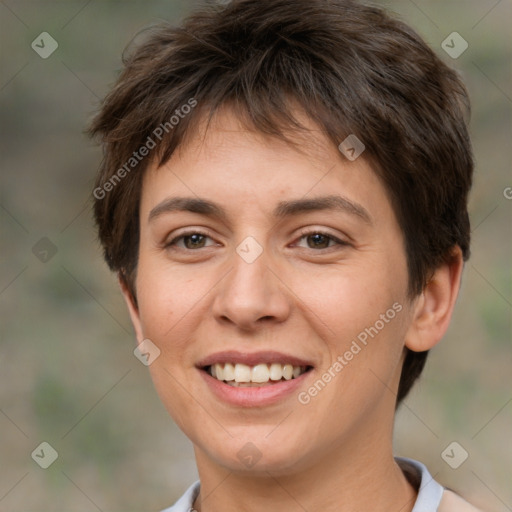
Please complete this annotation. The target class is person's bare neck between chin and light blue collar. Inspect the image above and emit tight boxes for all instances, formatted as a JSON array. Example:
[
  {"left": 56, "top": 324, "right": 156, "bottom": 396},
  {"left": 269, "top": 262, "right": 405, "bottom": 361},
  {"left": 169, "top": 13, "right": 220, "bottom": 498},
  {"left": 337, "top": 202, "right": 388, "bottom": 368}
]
[{"left": 194, "top": 414, "right": 416, "bottom": 512}]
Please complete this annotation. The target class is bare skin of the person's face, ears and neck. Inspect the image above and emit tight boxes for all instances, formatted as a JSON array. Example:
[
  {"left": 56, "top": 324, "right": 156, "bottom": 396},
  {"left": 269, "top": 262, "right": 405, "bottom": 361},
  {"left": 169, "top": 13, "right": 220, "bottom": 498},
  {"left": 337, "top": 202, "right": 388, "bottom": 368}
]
[{"left": 121, "top": 109, "right": 462, "bottom": 512}]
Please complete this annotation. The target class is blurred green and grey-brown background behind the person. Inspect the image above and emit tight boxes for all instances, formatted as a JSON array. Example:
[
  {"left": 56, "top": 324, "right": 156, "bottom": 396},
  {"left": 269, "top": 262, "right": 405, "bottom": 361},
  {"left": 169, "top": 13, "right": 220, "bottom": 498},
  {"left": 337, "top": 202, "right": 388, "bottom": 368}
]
[{"left": 0, "top": 0, "right": 512, "bottom": 512}]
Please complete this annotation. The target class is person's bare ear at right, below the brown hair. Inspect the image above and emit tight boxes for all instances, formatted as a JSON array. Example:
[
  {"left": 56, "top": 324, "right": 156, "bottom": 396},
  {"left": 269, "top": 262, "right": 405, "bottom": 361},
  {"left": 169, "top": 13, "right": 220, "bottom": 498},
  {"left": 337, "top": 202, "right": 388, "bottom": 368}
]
[{"left": 405, "top": 246, "right": 464, "bottom": 352}]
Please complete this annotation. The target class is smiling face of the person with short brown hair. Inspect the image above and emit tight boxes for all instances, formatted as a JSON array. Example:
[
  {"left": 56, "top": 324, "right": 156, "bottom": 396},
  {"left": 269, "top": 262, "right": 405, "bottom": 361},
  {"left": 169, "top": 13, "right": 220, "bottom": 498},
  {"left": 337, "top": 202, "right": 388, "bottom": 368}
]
[{"left": 125, "top": 111, "right": 420, "bottom": 474}]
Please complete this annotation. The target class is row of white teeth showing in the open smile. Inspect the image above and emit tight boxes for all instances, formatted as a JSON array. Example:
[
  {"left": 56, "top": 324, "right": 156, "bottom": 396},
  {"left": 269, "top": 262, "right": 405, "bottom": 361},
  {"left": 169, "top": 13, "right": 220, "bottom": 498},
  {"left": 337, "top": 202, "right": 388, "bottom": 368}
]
[{"left": 210, "top": 363, "right": 306, "bottom": 387}]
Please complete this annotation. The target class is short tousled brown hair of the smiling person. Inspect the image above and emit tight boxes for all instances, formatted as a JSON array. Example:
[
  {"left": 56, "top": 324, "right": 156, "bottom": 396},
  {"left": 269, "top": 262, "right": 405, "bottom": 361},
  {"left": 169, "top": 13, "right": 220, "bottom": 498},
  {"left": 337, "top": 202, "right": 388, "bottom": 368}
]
[{"left": 90, "top": 0, "right": 473, "bottom": 403}]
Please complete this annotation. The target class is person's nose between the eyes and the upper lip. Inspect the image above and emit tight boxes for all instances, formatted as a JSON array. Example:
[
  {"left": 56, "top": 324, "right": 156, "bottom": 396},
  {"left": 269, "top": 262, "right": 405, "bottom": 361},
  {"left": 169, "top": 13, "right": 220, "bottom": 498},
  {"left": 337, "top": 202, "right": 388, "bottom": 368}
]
[{"left": 213, "top": 244, "right": 291, "bottom": 331}]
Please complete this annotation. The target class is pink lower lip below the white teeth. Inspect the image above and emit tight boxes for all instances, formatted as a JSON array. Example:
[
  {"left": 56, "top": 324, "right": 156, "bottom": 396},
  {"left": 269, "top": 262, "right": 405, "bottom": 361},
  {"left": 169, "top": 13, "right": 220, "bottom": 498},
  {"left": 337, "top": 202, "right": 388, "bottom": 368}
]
[{"left": 198, "top": 370, "right": 311, "bottom": 407}]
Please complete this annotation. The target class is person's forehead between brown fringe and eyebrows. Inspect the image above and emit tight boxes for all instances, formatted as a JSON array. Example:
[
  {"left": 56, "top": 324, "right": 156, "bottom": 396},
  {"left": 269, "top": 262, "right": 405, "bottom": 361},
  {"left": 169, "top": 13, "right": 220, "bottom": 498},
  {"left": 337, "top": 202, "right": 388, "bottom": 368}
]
[{"left": 141, "top": 110, "right": 393, "bottom": 226}]
